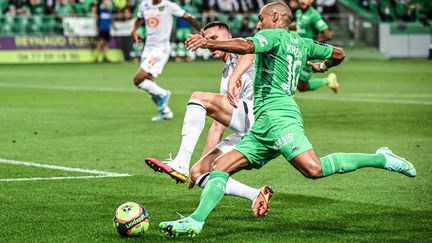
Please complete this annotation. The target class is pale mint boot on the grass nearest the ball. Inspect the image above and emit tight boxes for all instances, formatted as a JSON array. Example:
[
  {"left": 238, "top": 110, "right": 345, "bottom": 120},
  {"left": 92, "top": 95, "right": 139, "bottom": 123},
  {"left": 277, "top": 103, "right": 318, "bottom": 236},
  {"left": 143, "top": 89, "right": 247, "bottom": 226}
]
[{"left": 159, "top": 217, "right": 204, "bottom": 237}]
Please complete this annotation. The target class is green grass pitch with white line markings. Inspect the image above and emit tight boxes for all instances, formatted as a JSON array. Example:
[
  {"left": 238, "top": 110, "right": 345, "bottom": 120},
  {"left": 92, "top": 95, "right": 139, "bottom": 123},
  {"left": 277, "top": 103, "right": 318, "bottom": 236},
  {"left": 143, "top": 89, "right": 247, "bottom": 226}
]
[{"left": 0, "top": 60, "right": 432, "bottom": 242}]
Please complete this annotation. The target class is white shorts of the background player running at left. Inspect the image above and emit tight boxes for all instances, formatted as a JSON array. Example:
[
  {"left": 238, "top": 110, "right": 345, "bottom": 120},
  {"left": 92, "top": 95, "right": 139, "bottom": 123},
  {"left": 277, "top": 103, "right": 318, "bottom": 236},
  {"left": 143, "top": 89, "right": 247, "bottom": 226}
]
[{"left": 141, "top": 44, "right": 170, "bottom": 78}]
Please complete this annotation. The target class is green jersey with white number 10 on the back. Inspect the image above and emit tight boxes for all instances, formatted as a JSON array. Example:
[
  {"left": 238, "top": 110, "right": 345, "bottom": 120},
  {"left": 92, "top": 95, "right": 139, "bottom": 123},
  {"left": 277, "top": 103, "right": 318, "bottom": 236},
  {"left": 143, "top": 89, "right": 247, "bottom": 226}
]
[{"left": 247, "top": 29, "right": 333, "bottom": 118}]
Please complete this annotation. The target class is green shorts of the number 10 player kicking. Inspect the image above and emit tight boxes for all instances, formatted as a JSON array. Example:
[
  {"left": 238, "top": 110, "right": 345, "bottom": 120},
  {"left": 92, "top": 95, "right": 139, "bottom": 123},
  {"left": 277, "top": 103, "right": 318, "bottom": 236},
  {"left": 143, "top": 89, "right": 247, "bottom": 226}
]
[{"left": 234, "top": 110, "right": 312, "bottom": 169}]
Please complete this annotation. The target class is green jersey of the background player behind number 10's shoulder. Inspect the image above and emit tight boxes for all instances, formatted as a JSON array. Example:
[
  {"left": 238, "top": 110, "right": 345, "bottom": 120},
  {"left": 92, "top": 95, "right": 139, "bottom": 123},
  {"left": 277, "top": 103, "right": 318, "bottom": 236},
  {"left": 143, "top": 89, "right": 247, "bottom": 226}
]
[{"left": 296, "top": 7, "right": 329, "bottom": 39}]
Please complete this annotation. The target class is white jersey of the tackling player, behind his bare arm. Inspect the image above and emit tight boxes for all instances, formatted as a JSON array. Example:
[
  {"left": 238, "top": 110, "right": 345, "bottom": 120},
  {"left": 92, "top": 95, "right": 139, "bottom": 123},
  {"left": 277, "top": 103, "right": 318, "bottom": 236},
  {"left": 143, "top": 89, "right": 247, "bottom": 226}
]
[{"left": 220, "top": 54, "right": 255, "bottom": 100}]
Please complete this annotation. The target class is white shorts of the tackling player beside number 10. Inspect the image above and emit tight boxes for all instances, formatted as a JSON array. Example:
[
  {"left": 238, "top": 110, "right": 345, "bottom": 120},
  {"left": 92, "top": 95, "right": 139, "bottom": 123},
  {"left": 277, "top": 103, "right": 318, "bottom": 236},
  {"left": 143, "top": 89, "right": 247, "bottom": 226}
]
[{"left": 216, "top": 99, "right": 254, "bottom": 154}]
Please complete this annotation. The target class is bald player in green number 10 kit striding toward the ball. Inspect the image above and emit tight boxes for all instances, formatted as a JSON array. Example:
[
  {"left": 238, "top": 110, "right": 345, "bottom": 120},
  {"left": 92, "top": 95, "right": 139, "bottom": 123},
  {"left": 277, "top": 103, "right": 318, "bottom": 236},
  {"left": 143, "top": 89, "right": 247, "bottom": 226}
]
[{"left": 159, "top": 3, "right": 416, "bottom": 236}]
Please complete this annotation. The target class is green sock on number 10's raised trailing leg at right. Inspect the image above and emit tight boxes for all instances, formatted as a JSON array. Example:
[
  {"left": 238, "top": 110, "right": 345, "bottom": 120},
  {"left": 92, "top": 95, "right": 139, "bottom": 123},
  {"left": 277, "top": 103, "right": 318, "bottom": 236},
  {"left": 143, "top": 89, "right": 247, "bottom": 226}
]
[{"left": 320, "top": 153, "right": 386, "bottom": 176}]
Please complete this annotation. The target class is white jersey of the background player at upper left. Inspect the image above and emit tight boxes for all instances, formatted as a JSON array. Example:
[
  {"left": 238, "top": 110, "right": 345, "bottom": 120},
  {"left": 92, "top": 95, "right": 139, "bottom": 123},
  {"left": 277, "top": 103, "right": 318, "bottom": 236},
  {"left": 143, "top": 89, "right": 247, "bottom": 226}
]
[{"left": 137, "top": 0, "right": 185, "bottom": 46}]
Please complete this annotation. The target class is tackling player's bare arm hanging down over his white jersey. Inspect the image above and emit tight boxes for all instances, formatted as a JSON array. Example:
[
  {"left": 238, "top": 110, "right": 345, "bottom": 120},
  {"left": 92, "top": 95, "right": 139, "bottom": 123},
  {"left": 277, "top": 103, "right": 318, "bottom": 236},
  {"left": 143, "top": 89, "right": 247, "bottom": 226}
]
[{"left": 227, "top": 54, "right": 255, "bottom": 107}]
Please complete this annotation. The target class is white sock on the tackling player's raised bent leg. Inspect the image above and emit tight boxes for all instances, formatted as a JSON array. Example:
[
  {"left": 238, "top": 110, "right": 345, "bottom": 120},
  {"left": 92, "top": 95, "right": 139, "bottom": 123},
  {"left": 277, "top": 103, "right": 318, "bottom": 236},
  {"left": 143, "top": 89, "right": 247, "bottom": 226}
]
[{"left": 174, "top": 99, "right": 207, "bottom": 169}]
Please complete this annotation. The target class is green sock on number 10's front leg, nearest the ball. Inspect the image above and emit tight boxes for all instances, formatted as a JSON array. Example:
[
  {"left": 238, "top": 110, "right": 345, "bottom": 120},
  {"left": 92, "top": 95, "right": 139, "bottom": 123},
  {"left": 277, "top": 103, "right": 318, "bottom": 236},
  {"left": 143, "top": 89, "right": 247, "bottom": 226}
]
[{"left": 190, "top": 170, "right": 229, "bottom": 222}]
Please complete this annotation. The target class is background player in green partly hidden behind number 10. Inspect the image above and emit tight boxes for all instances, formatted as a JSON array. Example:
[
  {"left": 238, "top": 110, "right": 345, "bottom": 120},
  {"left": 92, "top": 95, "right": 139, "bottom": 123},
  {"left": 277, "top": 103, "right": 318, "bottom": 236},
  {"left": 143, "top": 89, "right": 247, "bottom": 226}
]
[{"left": 295, "top": 0, "right": 340, "bottom": 93}]
